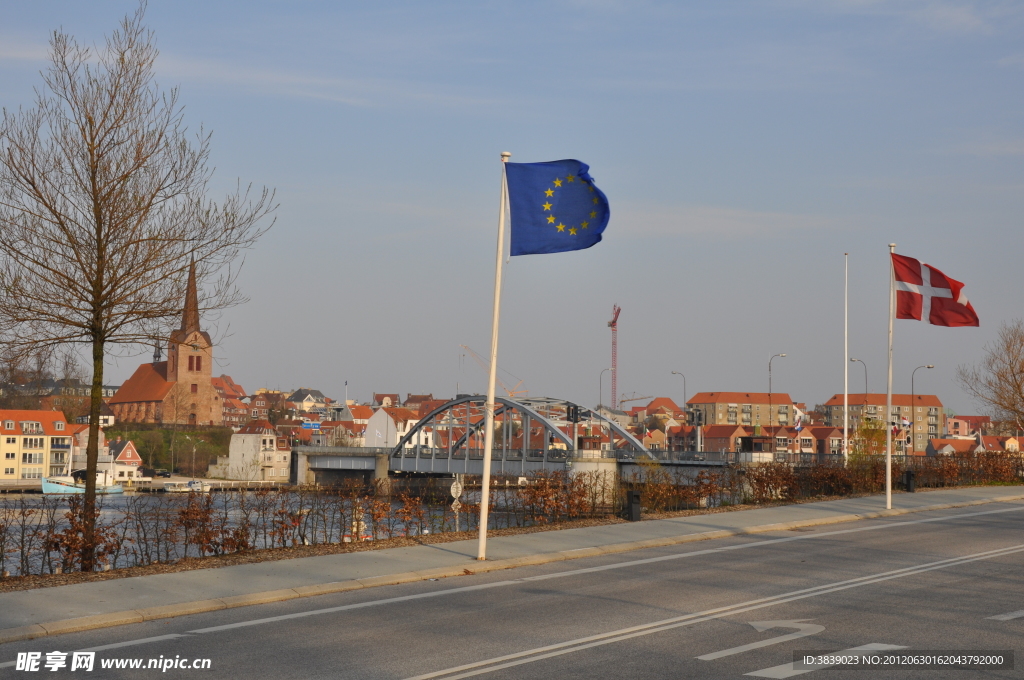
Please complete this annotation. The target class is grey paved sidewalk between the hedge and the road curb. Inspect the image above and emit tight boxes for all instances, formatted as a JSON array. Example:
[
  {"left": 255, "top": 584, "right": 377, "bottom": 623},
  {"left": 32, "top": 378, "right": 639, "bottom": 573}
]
[{"left": 0, "top": 486, "right": 1024, "bottom": 643}]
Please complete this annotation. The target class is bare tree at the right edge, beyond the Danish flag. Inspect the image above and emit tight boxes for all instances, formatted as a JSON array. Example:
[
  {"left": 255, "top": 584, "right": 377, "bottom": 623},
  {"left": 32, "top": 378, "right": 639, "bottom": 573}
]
[{"left": 956, "top": 320, "right": 1024, "bottom": 428}]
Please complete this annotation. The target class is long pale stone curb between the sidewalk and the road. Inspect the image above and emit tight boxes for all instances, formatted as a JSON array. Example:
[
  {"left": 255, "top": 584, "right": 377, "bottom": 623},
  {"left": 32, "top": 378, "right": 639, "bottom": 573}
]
[{"left": 0, "top": 494, "right": 1024, "bottom": 644}]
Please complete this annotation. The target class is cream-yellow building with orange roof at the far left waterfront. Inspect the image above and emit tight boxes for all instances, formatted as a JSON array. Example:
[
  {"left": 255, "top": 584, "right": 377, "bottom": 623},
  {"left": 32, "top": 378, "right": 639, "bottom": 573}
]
[{"left": 0, "top": 411, "right": 72, "bottom": 480}]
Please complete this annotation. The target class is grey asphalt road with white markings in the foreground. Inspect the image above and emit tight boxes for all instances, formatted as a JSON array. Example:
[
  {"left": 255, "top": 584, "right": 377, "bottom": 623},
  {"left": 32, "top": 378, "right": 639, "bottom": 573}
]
[{"left": 0, "top": 503, "right": 1024, "bottom": 680}]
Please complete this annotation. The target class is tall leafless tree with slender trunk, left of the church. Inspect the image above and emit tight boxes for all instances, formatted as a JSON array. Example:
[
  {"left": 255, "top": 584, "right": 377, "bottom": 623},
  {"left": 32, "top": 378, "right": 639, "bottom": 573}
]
[{"left": 0, "top": 5, "right": 274, "bottom": 570}]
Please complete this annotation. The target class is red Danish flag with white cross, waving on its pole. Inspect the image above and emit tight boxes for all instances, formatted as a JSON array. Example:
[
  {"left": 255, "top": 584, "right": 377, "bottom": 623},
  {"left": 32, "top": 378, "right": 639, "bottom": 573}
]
[{"left": 892, "top": 253, "right": 980, "bottom": 326}]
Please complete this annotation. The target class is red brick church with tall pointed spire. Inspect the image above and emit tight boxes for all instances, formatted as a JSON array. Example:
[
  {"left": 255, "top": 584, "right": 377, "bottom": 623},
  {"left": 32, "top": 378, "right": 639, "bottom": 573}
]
[{"left": 110, "top": 263, "right": 223, "bottom": 425}]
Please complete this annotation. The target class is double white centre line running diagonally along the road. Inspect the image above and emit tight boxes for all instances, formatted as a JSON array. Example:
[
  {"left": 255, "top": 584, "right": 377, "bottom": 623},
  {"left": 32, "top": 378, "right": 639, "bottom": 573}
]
[{"left": 407, "top": 545, "right": 1024, "bottom": 680}]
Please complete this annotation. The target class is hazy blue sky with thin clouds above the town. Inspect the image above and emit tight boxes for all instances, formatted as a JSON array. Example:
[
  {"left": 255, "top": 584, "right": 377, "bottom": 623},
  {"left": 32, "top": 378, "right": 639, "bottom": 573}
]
[{"left": 0, "top": 0, "right": 1024, "bottom": 413}]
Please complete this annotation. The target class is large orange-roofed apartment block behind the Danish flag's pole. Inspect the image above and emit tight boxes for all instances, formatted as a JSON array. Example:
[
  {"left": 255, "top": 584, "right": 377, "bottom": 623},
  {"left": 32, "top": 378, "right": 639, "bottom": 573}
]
[{"left": 824, "top": 393, "right": 946, "bottom": 451}]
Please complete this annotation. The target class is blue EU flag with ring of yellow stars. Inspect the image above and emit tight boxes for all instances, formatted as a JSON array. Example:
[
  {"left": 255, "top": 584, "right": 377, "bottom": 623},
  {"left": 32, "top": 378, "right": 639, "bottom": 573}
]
[{"left": 505, "top": 159, "right": 609, "bottom": 255}]
